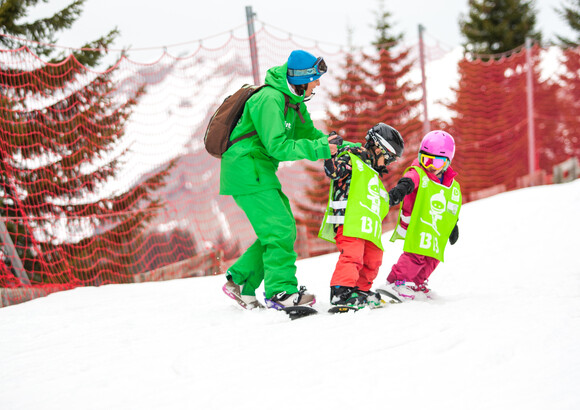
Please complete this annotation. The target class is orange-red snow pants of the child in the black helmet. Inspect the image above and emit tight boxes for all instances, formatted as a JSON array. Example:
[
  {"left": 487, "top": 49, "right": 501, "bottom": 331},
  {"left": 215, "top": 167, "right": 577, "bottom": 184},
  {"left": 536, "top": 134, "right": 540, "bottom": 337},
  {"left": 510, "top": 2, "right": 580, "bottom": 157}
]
[{"left": 330, "top": 225, "right": 383, "bottom": 290}]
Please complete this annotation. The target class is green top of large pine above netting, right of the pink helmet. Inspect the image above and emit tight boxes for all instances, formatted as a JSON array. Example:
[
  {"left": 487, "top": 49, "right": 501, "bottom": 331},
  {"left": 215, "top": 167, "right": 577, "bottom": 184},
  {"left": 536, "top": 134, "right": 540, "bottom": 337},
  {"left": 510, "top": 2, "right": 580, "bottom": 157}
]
[{"left": 459, "top": 0, "right": 542, "bottom": 55}]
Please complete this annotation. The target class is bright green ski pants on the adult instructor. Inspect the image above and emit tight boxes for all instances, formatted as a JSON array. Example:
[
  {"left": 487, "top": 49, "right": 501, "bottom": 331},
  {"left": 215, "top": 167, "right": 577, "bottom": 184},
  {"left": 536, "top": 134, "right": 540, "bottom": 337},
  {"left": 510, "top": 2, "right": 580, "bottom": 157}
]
[{"left": 229, "top": 189, "right": 298, "bottom": 298}]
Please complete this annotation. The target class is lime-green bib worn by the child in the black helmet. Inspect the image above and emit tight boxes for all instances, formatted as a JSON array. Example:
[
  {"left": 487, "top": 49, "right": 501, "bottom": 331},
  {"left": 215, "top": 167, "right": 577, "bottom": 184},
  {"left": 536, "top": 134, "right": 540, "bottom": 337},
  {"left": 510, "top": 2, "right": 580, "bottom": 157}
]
[{"left": 318, "top": 151, "right": 389, "bottom": 250}]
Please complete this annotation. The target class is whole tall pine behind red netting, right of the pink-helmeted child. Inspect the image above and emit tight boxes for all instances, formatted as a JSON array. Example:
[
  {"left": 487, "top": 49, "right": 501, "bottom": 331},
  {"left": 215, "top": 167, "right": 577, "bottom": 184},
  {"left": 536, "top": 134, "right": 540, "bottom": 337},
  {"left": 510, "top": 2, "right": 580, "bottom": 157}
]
[{"left": 450, "top": 0, "right": 554, "bottom": 199}]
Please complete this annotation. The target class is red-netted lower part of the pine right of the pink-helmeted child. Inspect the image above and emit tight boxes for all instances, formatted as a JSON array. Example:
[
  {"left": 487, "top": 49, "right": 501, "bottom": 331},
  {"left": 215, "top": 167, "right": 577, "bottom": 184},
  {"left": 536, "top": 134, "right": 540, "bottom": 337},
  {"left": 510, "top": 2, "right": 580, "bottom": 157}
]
[{"left": 449, "top": 52, "right": 527, "bottom": 200}]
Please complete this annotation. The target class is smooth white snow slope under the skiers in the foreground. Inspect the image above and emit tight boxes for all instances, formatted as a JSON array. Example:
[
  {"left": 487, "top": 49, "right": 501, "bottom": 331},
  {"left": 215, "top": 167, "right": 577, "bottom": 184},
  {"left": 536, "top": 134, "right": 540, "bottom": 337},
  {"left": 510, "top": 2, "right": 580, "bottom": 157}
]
[{"left": 0, "top": 180, "right": 580, "bottom": 410}]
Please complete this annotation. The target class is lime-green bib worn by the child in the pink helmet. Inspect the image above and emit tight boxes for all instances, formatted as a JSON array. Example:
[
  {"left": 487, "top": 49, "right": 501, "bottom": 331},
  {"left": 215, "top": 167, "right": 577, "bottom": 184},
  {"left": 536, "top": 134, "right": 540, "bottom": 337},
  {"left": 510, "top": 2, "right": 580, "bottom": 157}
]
[{"left": 391, "top": 166, "right": 461, "bottom": 262}]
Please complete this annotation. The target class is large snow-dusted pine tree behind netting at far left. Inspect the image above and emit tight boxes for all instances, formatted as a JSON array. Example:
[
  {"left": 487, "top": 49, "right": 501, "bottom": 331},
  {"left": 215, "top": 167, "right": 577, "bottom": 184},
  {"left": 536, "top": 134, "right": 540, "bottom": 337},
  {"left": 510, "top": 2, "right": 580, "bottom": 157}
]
[{"left": 0, "top": 0, "right": 166, "bottom": 286}]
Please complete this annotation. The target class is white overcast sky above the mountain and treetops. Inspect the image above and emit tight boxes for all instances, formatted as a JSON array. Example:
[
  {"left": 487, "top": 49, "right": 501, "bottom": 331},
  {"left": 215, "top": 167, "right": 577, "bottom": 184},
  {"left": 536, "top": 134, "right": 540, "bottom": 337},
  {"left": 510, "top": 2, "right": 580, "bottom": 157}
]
[{"left": 28, "top": 0, "right": 571, "bottom": 62}]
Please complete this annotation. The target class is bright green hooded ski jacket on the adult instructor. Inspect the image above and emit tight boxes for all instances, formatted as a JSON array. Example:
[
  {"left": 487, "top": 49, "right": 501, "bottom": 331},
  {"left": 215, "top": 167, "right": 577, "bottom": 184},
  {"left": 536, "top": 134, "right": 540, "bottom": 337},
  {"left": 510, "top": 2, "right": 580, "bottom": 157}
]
[{"left": 220, "top": 64, "right": 330, "bottom": 195}]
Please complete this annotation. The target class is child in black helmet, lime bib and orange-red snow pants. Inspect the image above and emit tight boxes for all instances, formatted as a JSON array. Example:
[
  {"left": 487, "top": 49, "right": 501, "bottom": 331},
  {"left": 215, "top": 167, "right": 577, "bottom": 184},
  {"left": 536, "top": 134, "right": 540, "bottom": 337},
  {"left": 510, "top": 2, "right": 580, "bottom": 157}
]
[{"left": 319, "top": 123, "right": 404, "bottom": 309}]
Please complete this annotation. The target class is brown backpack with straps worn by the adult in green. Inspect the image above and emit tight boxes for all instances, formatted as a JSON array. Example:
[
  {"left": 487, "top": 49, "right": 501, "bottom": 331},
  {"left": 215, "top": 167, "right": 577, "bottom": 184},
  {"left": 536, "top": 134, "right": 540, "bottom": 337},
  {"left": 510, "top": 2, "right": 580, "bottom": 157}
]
[{"left": 203, "top": 84, "right": 304, "bottom": 158}]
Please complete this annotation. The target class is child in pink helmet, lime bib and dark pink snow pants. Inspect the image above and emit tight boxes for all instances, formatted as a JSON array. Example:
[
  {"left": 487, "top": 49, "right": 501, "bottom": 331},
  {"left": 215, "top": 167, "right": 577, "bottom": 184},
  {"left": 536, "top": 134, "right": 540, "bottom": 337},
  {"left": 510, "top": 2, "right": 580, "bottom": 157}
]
[{"left": 377, "top": 130, "right": 461, "bottom": 302}]
